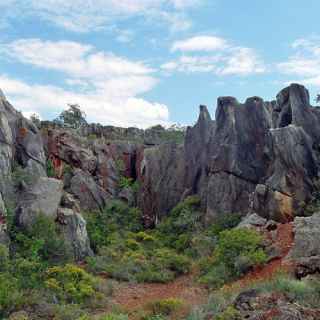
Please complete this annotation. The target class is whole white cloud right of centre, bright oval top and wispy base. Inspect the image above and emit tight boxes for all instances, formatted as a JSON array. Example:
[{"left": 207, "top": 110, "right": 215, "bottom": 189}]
[{"left": 161, "top": 36, "right": 266, "bottom": 76}]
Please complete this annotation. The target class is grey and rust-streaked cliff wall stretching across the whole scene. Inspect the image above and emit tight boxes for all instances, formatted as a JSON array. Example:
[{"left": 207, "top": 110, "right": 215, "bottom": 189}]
[{"left": 0, "top": 84, "right": 320, "bottom": 258}]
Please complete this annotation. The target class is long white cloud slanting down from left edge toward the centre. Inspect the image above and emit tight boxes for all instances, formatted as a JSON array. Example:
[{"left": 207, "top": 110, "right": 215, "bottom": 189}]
[{"left": 0, "top": 39, "right": 152, "bottom": 80}]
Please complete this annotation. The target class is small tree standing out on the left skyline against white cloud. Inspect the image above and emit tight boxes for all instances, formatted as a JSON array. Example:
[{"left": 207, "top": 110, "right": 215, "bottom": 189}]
[{"left": 54, "top": 104, "right": 87, "bottom": 129}]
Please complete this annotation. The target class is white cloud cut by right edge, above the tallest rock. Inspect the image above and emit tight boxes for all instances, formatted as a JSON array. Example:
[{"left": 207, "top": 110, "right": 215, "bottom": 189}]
[{"left": 277, "top": 37, "right": 320, "bottom": 86}]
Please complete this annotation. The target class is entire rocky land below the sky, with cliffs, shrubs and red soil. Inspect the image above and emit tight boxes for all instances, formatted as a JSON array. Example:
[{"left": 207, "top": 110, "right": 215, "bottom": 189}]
[{"left": 0, "top": 84, "right": 320, "bottom": 320}]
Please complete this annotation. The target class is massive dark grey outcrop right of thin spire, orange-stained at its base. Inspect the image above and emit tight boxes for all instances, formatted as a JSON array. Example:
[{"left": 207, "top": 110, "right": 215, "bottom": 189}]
[{"left": 207, "top": 84, "right": 319, "bottom": 221}]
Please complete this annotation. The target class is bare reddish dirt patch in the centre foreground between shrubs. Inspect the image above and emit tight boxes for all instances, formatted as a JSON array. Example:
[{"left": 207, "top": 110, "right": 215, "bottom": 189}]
[{"left": 113, "top": 275, "right": 208, "bottom": 311}]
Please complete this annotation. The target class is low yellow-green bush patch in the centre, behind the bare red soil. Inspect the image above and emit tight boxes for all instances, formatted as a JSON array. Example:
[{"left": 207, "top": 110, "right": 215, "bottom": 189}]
[{"left": 87, "top": 232, "right": 190, "bottom": 282}]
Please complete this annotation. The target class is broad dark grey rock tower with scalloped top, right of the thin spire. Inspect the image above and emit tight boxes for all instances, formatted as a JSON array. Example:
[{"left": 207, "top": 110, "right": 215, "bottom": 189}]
[{"left": 207, "top": 97, "right": 272, "bottom": 218}]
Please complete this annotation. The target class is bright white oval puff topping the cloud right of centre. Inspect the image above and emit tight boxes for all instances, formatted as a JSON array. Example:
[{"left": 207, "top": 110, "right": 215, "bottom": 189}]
[{"left": 171, "top": 36, "right": 228, "bottom": 52}]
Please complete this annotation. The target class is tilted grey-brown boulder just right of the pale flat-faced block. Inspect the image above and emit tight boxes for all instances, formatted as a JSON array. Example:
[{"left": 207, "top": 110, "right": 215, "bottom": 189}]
[{"left": 69, "top": 169, "right": 110, "bottom": 210}]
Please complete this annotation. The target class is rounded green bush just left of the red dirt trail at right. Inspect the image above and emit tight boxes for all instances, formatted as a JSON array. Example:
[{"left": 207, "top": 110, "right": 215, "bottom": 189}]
[{"left": 201, "top": 229, "right": 267, "bottom": 288}]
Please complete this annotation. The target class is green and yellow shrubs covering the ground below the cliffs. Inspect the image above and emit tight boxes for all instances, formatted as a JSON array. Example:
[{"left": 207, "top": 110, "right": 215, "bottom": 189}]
[{"left": 0, "top": 196, "right": 276, "bottom": 320}]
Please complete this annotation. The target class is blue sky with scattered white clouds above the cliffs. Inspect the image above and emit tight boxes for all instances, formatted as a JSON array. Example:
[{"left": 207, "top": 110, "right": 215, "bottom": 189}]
[{"left": 0, "top": 0, "right": 320, "bottom": 128}]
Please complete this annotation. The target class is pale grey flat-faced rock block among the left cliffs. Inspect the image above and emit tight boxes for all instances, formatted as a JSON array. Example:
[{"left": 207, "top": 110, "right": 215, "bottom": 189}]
[{"left": 16, "top": 177, "right": 63, "bottom": 228}]
